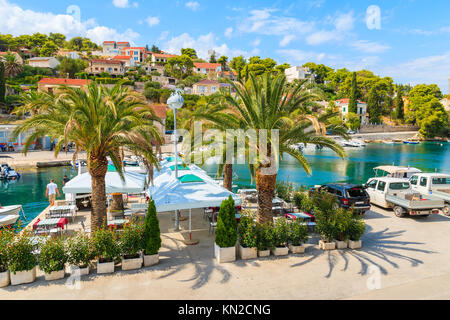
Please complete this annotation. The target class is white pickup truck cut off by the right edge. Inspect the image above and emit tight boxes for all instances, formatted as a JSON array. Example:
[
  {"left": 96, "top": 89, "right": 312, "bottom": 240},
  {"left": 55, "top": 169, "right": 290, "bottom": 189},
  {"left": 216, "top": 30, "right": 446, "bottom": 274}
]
[{"left": 409, "top": 173, "right": 450, "bottom": 216}]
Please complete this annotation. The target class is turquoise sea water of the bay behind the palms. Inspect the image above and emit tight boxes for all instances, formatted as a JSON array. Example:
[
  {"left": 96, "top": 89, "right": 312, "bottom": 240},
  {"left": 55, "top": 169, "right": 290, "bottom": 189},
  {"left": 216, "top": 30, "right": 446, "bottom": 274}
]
[{"left": 0, "top": 143, "right": 450, "bottom": 229}]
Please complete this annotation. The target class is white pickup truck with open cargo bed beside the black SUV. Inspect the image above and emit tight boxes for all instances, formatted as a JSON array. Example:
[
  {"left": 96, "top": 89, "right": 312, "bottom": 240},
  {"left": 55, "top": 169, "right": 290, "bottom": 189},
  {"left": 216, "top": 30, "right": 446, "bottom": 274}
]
[{"left": 365, "top": 177, "right": 444, "bottom": 217}]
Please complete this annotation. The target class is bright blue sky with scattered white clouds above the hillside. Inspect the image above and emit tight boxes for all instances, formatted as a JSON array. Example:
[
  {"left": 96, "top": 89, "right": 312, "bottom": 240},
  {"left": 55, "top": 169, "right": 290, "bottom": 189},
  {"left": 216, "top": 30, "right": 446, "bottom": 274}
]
[{"left": 0, "top": 0, "right": 450, "bottom": 93}]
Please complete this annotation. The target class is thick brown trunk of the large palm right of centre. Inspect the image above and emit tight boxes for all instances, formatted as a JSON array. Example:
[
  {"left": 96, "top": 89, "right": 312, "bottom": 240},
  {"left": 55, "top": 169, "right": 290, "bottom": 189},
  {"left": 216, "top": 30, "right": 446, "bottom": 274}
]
[{"left": 256, "top": 171, "right": 277, "bottom": 224}]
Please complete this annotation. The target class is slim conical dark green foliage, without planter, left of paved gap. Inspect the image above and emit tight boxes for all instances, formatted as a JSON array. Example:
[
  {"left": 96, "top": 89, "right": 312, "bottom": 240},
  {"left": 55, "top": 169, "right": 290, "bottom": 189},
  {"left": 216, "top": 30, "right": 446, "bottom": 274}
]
[{"left": 143, "top": 199, "right": 161, "bottom": 255}]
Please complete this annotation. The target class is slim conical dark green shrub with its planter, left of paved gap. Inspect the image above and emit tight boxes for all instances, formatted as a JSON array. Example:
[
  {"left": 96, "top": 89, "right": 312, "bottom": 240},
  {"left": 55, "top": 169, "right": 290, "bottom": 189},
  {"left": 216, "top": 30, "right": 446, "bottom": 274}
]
[{"left": 141, "top": 199, "right": 161, "bottom": 267}]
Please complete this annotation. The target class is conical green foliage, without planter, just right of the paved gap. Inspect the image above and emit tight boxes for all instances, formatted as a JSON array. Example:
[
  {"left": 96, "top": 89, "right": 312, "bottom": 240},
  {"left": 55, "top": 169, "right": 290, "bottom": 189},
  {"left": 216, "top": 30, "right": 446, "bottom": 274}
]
[{"left": 215, "top": 196, "right": 237, "bottom": 248}]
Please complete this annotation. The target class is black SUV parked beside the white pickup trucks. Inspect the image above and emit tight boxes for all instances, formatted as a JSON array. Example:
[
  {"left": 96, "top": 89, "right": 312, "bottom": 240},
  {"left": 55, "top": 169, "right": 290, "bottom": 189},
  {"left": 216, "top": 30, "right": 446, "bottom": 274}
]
[{"left": 310, "top": 183, "right": 370, "bottom": 214}]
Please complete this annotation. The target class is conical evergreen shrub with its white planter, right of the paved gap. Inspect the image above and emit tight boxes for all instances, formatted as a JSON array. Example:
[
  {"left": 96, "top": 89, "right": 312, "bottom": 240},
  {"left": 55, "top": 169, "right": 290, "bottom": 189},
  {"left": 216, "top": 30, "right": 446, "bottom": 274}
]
[{"left": 214, "top": 196, "right": 237, "bottom": 263}]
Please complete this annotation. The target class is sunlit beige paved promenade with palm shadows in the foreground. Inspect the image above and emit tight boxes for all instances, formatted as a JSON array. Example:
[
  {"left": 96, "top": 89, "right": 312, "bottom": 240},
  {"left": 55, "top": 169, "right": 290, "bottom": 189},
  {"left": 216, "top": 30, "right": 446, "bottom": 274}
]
[{"left": 0, "top": 208, "right": 450, "bottom": 300}]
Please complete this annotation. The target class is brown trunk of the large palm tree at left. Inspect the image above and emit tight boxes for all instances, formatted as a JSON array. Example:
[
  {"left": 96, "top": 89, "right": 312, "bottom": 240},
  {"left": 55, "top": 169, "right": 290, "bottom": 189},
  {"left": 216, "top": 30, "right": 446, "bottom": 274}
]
[{"left": 88, "top": 155, "right": 108, "bottom": 232}]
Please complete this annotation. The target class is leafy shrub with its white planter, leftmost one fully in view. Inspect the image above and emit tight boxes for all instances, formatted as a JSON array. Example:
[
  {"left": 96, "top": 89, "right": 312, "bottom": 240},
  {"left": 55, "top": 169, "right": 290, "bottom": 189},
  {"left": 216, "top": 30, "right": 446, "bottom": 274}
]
[{"left": 8, "top": 232, "right": 37, "bottom": 286}]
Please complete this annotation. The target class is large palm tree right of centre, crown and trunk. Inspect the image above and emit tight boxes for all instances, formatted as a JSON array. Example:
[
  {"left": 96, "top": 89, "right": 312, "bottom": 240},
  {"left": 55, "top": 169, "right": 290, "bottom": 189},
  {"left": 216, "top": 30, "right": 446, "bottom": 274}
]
[{"left": 211, "top": 73, "right": 345, "bottom": 223}]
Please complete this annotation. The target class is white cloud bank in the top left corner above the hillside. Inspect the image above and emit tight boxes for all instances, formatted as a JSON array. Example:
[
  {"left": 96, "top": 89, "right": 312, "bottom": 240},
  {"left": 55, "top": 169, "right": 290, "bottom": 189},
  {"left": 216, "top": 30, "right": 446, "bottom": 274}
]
[{"left": 0, "top": 0, "right": 140, "bottom": 44}]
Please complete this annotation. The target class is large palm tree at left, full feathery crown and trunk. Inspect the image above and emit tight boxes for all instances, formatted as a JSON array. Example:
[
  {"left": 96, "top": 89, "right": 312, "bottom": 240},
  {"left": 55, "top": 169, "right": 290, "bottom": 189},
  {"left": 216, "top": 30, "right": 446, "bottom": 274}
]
[{"left": 13, "top": 82, "right": 162, "bottom": 231}]
